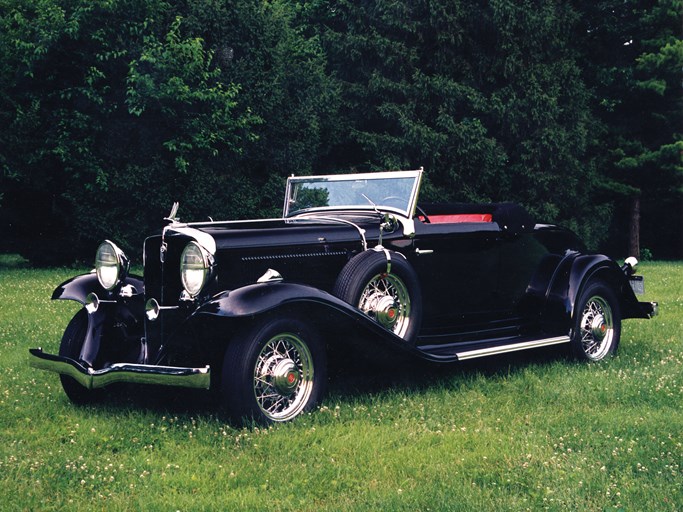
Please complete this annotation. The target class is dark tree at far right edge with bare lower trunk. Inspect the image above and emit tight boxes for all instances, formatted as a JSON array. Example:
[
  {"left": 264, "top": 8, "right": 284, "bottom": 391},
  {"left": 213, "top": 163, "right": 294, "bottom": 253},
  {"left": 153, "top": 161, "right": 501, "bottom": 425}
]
[{"left": 575, "top": 0, "right": 683, "bottom": 257}]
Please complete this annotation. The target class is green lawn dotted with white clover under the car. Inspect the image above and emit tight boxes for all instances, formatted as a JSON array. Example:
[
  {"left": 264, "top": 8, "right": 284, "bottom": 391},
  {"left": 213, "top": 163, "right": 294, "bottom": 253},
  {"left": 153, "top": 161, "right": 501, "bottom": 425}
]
[{"left": 0, "top": 256, "right": 683, "bottom": 511}]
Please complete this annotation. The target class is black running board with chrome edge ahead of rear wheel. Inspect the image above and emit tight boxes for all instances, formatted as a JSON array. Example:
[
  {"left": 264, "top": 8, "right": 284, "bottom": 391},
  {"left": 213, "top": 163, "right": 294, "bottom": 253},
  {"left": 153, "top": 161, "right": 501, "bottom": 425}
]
[{"left": 417, "top": 336, "right": 571, "bottom": 363}]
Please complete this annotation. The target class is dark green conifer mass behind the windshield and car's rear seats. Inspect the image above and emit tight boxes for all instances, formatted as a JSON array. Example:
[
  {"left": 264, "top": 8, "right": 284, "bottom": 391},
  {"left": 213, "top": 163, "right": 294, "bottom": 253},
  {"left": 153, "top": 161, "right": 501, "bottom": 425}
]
[{"left": 303, "top": 0, "right": 600, "bottom": 246}]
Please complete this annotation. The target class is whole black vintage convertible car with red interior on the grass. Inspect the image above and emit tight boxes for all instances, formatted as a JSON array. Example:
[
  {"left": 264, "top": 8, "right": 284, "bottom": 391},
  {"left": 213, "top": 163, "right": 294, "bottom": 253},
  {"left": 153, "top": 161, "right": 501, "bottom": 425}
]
[{"left": 30, "top": 170, "right": 657, "bottom": 422}]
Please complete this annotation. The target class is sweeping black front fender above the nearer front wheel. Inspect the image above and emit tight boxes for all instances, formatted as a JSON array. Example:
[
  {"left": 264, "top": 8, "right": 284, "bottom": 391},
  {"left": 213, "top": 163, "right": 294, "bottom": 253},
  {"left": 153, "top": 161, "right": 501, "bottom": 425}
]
[{"left": 192, "top": 282, "right": 416, "bottom": 355}]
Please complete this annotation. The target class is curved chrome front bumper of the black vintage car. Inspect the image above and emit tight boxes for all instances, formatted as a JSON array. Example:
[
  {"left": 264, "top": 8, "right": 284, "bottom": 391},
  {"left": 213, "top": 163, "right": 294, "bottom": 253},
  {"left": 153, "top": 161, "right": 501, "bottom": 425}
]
[{"left": 28, "top": 348, "right": 211, "bottom": 389}]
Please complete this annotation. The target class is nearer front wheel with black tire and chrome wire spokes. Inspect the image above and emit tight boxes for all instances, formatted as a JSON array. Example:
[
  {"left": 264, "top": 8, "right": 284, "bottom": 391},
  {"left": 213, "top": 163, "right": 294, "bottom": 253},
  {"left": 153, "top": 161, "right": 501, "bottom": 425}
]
[{"left": 221, "top": 318, "right": 327, "bottom": 423}]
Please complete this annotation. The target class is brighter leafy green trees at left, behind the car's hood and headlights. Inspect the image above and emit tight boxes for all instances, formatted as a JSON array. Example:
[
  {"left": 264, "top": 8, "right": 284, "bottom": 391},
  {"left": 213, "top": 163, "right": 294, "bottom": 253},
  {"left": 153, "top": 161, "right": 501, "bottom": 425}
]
[{"left": 0, "top": 0, "right": 334, "bottom": 262}]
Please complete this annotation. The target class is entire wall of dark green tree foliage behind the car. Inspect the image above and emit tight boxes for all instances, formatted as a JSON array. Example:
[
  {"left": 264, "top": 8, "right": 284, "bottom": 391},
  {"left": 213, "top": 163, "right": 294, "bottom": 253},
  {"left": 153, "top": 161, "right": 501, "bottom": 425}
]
[{"left": 0, "top": 0, "right": 683, "bottom": 263}]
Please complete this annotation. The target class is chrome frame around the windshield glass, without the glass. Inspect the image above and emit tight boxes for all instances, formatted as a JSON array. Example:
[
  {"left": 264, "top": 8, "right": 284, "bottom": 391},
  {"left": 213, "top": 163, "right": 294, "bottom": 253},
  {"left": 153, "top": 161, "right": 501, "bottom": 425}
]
[{"left": 282, "top": 168, "right": 423, "bottom": 219}]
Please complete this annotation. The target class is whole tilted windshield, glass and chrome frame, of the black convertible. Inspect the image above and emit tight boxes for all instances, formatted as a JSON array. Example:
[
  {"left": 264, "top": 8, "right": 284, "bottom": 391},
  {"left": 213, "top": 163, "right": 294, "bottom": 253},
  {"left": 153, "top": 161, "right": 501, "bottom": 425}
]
[{"left": 284, "top": 170, "right": 422, "bottom": 217}]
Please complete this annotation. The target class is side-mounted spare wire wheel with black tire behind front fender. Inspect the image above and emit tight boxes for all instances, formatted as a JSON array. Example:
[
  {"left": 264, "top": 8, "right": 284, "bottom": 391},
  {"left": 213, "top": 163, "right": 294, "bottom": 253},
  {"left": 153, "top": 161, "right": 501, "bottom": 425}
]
[{"left": 333, "top": 250, "right": 422, "bottom": 343}]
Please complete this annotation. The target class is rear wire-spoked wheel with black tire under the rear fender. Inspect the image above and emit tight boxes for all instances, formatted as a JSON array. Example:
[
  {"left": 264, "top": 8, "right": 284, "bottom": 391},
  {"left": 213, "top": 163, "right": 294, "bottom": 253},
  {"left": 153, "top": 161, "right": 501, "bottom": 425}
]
[{"left": 571, "top": 280, "right": 621, "bottom": 361}]
